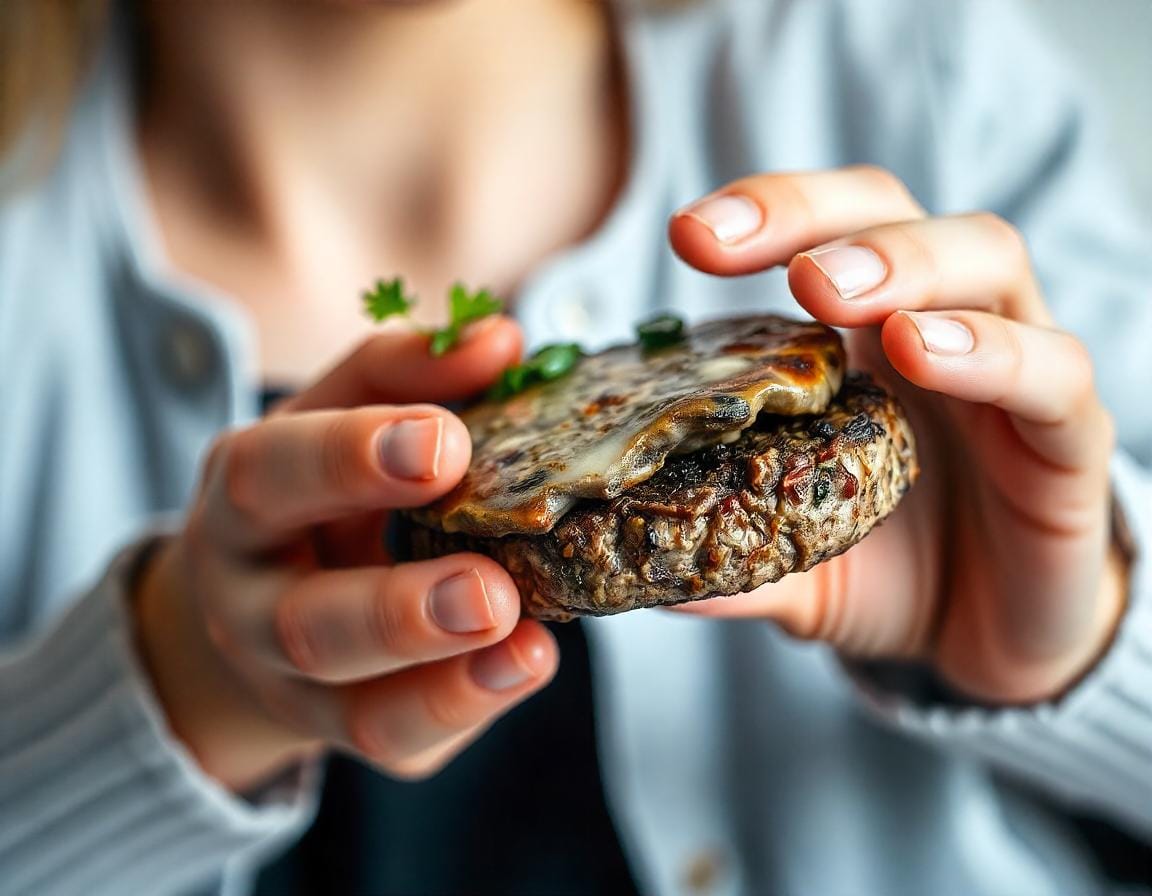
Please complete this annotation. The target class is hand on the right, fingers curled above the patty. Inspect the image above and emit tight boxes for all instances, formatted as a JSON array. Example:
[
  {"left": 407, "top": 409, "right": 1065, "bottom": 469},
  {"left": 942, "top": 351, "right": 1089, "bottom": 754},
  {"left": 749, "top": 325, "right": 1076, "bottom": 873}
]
[{"left": 670, "top": 167, "right": 1124, "bottom": 703}]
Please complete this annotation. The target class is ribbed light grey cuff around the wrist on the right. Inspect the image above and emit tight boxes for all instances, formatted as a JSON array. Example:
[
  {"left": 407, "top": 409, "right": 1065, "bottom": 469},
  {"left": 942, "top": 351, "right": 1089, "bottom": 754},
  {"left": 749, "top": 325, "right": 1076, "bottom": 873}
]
[{"left": 857, "top": 457, "right": 1152, "bottom": 837}]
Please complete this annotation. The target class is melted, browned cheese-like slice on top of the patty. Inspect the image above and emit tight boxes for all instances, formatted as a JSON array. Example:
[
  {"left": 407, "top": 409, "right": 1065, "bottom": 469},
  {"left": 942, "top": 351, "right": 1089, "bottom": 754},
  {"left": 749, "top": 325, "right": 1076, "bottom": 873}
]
[{"left": 415, "top": 314, "right": 844, "bottom": 537}]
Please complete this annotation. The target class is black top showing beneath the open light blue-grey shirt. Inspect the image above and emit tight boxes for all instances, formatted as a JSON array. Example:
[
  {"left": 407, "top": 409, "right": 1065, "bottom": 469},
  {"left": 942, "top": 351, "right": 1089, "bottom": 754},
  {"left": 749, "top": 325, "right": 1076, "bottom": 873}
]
[{"left": 255, "top": 390, "right": 636, "bottom": 896}]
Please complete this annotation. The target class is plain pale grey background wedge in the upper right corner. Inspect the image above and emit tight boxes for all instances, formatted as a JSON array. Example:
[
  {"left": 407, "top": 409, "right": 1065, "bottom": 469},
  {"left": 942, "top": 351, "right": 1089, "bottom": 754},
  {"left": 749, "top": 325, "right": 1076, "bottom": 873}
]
[{"left": 1026, "top": 0, "right": 1152, "bottom": 212}]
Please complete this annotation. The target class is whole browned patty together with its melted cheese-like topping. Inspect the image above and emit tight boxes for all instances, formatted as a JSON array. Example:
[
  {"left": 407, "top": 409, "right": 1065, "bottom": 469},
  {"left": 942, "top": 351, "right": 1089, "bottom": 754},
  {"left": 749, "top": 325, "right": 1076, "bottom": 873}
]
[{"left": 399, "top": 316, "right": 917, "bottom": 620}]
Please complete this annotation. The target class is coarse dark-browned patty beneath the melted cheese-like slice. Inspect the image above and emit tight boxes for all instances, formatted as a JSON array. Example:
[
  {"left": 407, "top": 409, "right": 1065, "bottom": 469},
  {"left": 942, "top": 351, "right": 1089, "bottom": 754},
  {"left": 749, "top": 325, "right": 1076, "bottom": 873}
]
[{"left": 401, "top": 374, "right": 917, "bottom": 620}]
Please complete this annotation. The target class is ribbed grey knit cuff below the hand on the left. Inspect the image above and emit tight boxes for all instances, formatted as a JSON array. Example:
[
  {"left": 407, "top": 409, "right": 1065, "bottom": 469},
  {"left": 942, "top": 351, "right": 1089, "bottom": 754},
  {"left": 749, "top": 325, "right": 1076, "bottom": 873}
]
[{"left": 0, "top": 536, "right": 311, "bottom": 896}]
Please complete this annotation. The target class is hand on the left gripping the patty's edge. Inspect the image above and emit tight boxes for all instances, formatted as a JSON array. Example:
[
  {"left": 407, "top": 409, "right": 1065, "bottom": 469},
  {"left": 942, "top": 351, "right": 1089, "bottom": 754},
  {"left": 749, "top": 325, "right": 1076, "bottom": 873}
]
[{"left": 136, "top": 319, "right": 558, "bottom": 791}]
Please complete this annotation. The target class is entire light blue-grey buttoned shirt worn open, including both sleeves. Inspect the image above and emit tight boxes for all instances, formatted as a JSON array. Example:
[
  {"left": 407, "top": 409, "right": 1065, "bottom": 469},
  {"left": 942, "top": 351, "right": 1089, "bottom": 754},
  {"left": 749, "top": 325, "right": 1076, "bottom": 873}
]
[{"left": 0, "top": 0, "right": 1152, "bottom": 896}]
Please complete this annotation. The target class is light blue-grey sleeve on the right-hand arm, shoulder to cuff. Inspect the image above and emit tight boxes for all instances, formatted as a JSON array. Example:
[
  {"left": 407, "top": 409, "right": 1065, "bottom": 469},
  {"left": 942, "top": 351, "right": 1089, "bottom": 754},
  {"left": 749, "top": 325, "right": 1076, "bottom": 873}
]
[{"left": 852, "top": 0, "right": 1152, "bottom": 837}]
